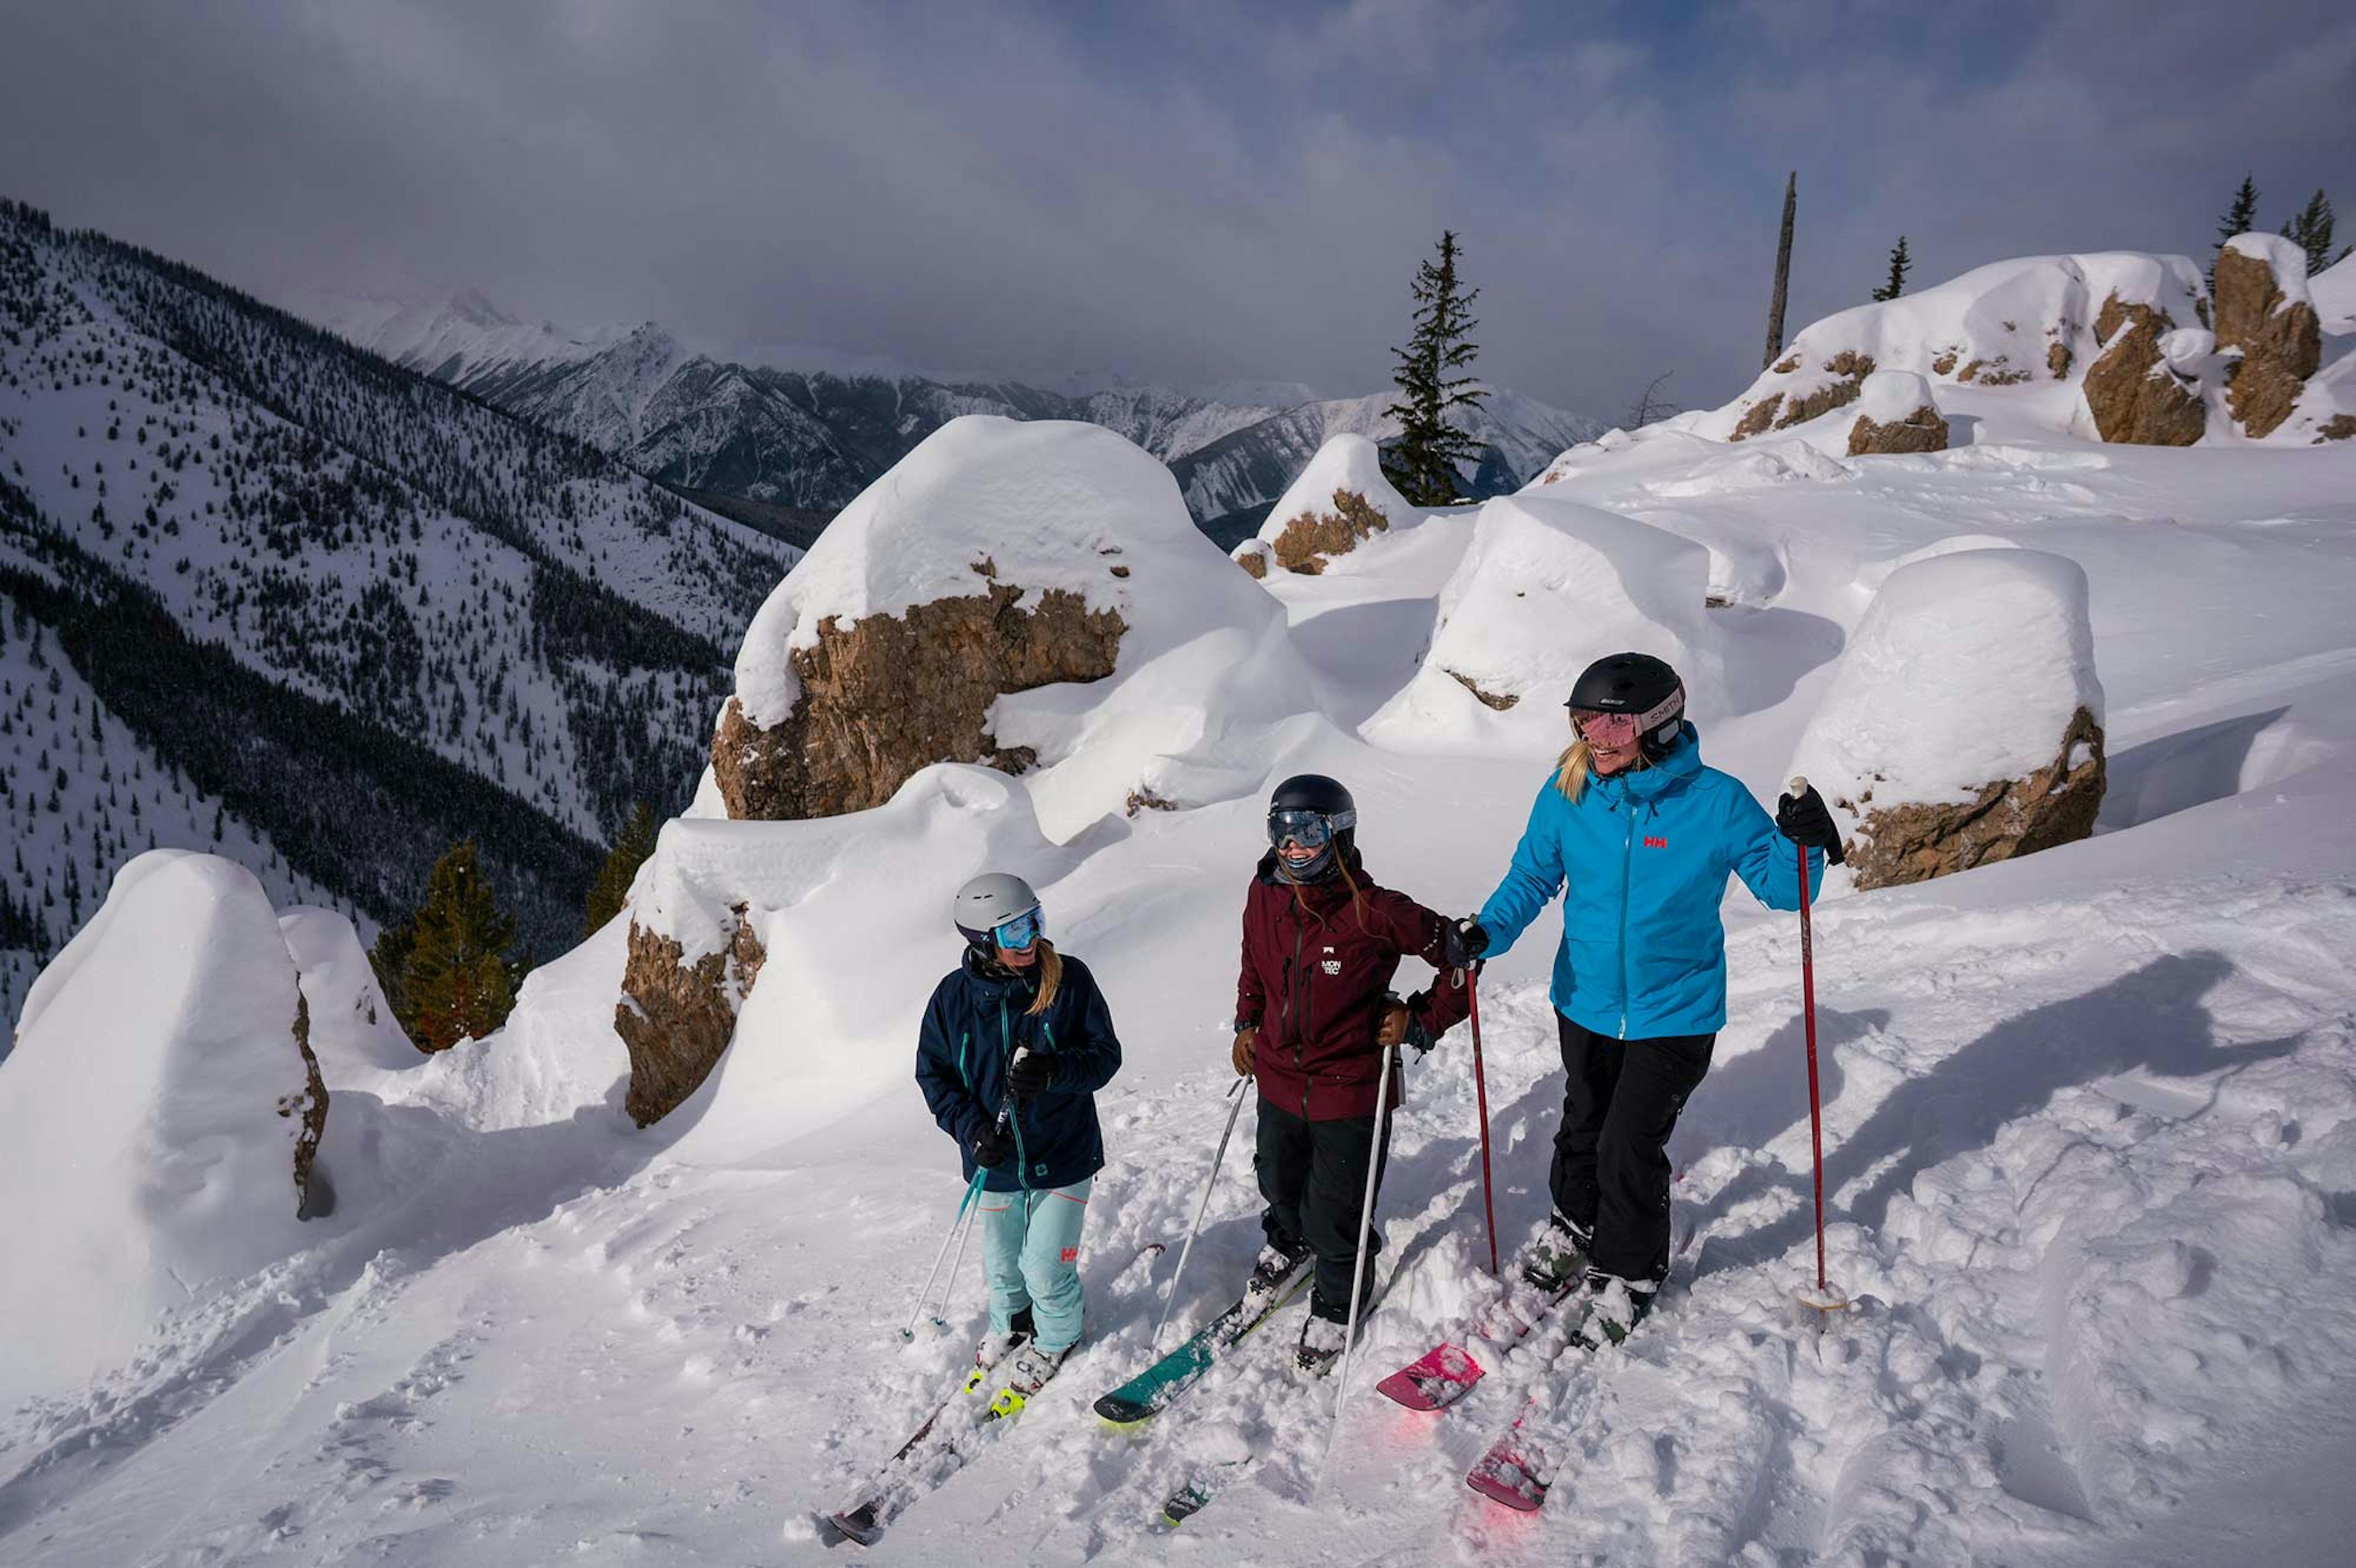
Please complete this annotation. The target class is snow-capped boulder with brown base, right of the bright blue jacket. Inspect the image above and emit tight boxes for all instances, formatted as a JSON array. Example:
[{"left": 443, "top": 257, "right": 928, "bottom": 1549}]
[{"left": 1793, "top": 548, "right": 2104, "bottom": 888}]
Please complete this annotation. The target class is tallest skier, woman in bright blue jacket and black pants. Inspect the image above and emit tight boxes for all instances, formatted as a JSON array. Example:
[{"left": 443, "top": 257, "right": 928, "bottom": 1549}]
[{"left": 1465, "top": 652, "right": 1840, "bottom": 1342}]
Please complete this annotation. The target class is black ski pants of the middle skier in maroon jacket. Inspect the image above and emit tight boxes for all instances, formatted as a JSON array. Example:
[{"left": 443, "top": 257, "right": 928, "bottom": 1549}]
[{"left": 1251, "top": 1095, "right": 1390, "bottom": 1323}]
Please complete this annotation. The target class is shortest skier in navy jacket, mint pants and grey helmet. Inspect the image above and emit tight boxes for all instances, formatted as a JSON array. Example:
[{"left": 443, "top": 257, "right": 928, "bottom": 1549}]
[{"left": 917, "top": 871, "right": 1122, "bottom": 1408}]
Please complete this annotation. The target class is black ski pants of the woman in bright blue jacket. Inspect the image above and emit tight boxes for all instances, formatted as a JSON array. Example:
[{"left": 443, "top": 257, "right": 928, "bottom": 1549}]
[{"left": 1550, "top": 1012, "right": 1717, "bottom": 1281}]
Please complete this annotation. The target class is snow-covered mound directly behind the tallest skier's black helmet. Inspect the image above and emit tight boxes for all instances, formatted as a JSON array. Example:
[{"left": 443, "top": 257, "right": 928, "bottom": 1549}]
[{"left": 1362, "top": 492, "right": 1720, "bottom": 756}]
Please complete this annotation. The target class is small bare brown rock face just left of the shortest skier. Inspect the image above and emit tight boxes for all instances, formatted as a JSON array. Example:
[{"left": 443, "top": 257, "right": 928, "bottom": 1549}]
[{"left": 612, "top": 904, "right": 768, "bottom": 1128}]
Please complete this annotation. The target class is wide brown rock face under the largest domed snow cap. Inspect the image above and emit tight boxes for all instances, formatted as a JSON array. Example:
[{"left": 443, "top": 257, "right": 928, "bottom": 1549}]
[{"left": 712, "top": 572, "right": 1126, "bottom": 821}]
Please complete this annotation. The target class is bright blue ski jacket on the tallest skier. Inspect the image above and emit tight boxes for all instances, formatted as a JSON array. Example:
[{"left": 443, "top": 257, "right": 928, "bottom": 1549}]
[{"left": 1480, "top": 723, "right": 1823, "bottom": 1040}]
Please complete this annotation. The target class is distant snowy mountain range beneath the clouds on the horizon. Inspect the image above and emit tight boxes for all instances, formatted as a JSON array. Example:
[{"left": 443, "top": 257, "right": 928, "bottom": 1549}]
[{"left": 299, "top": 290, "right": 1604, "bottom": 544}]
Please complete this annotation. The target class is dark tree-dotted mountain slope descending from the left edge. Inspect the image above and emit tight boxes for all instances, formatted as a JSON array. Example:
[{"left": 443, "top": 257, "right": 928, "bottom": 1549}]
[{"left": 0, "top": 205, "right": 796, "bottom": 1012}]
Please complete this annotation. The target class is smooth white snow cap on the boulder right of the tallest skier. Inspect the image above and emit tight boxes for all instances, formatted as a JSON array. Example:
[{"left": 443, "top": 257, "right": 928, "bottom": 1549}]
[{"left": 1790, "top": 548, "right": 2104, "bottom": 817}]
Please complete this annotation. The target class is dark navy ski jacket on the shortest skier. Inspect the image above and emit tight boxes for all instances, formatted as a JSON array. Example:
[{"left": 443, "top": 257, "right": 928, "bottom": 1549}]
[{"left": 917, "top": 949, "right": 1122, "bottom": 1191}]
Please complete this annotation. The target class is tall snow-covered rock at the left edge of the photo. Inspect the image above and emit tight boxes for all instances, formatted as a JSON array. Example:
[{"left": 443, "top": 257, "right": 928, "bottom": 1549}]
[{"left": 0, "top": 850, "right": 328, "bottom": 1405}]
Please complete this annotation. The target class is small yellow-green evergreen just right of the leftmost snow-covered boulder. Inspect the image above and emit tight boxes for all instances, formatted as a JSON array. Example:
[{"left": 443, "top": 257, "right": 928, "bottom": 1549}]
[{"left": 377, "top": 838, "right": 518, "bottom": 1050}]
